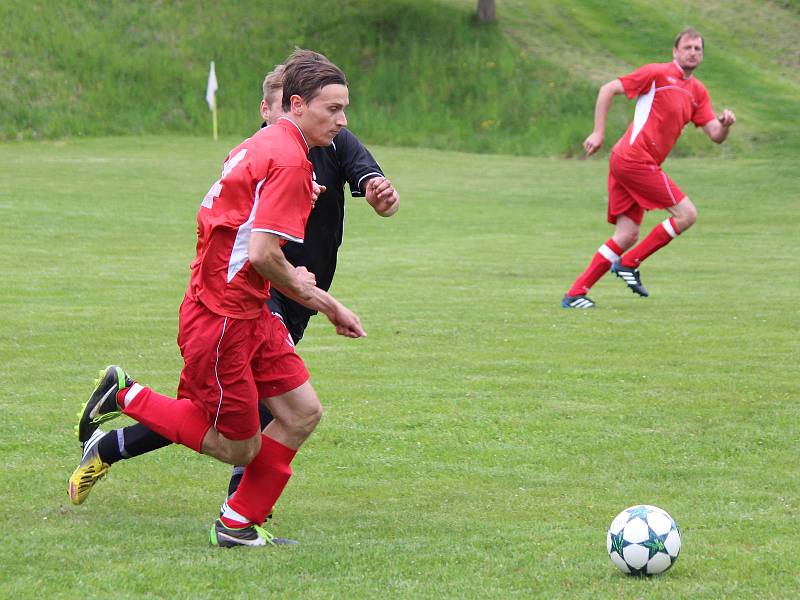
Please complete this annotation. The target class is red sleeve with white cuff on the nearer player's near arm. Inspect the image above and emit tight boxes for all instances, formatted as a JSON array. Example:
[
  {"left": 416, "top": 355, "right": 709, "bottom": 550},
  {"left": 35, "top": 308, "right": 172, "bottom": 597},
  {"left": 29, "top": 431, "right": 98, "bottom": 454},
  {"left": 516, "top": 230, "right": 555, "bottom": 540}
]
[{"left": 253, "top": 164, "right": 312, "bottom": 243}]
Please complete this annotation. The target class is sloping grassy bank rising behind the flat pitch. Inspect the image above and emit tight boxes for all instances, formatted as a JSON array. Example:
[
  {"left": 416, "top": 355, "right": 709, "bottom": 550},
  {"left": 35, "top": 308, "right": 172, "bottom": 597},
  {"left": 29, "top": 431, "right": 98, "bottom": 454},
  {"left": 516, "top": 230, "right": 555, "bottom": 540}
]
[{"left": 0, "top": 0, "right": 800, "bottom": 157}]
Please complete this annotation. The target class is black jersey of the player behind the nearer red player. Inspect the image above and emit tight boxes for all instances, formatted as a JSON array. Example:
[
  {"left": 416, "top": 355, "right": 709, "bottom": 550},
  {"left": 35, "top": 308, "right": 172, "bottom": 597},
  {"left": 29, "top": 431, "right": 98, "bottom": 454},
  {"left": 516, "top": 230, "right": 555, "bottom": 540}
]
[{"left": 269, "top": 129, "right": 383, "bottom": 342}]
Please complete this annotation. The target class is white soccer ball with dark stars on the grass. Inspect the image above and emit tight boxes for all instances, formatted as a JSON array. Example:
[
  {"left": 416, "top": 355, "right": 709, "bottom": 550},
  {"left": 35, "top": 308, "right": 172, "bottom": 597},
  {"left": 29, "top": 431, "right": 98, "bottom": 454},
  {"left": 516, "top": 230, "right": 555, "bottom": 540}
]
[{"left": 606, "top": 504, "right": 681, "bottom": 575}]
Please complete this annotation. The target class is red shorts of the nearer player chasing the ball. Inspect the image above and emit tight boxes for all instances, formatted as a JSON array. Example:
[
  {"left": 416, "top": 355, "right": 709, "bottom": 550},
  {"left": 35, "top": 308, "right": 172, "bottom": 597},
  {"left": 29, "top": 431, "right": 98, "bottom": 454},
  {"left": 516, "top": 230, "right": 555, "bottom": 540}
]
[{"left": 178, "top": 297, "right": 308, "bottom": 440}]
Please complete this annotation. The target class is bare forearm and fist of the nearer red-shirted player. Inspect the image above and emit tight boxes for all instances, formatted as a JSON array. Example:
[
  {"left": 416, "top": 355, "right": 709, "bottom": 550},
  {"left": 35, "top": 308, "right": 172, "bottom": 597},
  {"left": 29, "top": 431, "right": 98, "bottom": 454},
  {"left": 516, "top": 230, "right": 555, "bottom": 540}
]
[{"left": 248, "top": 231, "right": 367, "bottom": 338}]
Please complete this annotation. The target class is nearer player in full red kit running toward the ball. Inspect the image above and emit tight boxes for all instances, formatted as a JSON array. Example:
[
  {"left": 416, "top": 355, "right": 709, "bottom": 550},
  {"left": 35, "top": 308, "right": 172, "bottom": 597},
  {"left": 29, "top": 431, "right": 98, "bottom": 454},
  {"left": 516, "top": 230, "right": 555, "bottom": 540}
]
[{"left": 70, "top": 50, "right": 365, "bottom": 546}]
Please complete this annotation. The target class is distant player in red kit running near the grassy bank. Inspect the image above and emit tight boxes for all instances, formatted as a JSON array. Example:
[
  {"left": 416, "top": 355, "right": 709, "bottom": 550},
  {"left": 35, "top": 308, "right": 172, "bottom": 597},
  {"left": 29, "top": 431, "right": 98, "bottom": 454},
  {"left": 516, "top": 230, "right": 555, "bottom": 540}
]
[{"left": 561, "top": 28, "right": 736, "bottom": 308}]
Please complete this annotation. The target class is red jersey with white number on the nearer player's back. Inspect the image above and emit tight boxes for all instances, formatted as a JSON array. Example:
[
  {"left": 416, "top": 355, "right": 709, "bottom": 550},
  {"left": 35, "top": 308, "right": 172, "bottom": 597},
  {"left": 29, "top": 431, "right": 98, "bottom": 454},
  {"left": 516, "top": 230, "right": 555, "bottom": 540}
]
[{"left": 186, "top": 118, "right": 313, "bottom": 319}]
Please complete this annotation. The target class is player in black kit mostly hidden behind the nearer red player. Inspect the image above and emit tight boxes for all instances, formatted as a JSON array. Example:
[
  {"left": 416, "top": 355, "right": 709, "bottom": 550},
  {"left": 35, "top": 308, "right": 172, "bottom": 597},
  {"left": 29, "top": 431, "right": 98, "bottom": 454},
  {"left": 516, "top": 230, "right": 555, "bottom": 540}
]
[{"left": 70, "top": 65, "right": 400, "bottom": 504}]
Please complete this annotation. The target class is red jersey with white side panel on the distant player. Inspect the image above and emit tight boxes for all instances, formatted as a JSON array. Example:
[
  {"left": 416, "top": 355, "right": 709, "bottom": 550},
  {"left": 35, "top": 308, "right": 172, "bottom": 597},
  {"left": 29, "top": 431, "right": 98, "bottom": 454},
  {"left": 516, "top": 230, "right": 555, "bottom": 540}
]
[{"left": 613, "top": 62, "right": 715, "bottom": 165}]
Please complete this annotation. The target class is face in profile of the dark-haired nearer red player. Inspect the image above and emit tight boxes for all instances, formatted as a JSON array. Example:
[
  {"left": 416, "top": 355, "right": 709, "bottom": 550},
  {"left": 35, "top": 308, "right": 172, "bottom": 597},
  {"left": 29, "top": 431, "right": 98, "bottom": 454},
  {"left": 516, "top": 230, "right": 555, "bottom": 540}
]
[{"left": 292, "top": 83, "right": 350, "bottom": 147}]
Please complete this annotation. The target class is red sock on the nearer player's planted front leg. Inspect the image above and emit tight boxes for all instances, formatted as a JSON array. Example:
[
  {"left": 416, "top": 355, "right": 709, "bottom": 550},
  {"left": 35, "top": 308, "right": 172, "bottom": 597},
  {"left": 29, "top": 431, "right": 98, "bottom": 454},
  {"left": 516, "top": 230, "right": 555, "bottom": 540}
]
[{"left": 228, "top": 434, "right": 297, "bottom": 524}]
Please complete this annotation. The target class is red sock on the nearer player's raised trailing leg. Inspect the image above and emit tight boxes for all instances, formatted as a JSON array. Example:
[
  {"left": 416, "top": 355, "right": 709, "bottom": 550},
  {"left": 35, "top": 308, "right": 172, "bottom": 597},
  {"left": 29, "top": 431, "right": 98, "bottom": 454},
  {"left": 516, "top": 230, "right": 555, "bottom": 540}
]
[{"left": 117, "top": 383, "right": 211, "bottom": 452}]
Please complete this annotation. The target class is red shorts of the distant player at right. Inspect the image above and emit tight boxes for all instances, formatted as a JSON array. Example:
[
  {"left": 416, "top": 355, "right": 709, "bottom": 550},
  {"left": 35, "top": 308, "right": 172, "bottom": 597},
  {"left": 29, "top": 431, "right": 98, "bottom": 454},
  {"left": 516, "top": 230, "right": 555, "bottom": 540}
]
[{"left": 608, "top": 152, "right": 686, "bottom": 225}]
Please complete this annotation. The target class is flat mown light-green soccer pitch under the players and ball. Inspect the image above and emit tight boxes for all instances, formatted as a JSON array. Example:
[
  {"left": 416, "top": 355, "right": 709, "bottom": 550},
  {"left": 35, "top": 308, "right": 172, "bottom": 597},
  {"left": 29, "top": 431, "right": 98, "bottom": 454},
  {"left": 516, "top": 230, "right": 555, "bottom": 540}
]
[{"left": 0, "top": 137, "right": 800, "bottom": 599}]
